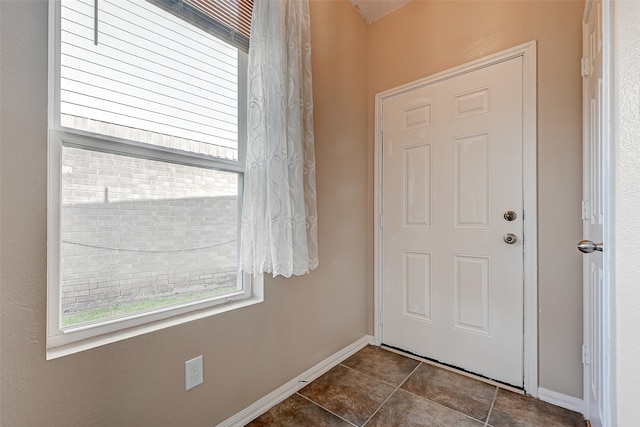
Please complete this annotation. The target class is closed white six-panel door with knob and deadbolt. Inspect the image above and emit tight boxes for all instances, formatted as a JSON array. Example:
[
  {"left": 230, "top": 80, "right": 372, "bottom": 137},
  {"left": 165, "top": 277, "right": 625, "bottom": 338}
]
[{"left": 382, "top": 57, "right": 523, "bottom": 387}]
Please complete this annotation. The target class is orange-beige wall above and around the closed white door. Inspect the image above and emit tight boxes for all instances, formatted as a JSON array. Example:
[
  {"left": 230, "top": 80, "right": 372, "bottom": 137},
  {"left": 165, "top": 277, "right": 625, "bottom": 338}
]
[{"left": 367, "top": 0, "right": 583, "bottom": 398}]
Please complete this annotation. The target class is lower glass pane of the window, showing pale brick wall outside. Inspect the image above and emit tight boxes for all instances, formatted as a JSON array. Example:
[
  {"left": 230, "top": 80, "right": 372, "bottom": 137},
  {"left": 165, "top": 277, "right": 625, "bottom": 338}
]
[{"left": 60, "top": 146, "right": 242, "bottom": 327}]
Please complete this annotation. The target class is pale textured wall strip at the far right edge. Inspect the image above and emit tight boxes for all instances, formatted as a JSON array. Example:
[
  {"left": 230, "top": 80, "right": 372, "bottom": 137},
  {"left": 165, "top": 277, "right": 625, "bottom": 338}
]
[{"left": 605, "top": 0, "right": 640, "bottom": 426}]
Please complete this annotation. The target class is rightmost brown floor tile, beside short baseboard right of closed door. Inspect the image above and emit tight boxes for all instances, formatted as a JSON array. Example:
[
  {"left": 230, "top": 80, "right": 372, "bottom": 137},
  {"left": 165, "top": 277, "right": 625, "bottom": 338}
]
[{"left": 489, "top": 389, "right": 585, "bottom": 427}]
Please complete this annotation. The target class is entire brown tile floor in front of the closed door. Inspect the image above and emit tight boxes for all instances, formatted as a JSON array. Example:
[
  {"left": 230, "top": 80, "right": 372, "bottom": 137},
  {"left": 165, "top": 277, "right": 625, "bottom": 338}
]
[{"left": 248, "top": 346, "right": 585, "bottom": 427}]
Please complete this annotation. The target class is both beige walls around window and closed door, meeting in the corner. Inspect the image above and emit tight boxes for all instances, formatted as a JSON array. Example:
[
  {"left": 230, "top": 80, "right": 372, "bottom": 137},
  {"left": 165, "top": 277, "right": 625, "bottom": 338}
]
[{"left": 0, "top": 0, "right": 582, "bottom": 427}]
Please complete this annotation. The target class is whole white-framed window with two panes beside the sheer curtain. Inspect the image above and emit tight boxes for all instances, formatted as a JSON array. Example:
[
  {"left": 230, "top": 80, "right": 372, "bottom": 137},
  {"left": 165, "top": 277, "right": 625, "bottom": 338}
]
[{"left": 47, "top": 0, "right": 261, "bottom": 358}]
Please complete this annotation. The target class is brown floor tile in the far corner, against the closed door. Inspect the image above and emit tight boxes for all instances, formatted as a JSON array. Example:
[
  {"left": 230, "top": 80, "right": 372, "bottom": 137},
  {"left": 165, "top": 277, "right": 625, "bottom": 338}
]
[{"left": 342, "top": 345, "right": 420, "bottom": 386}]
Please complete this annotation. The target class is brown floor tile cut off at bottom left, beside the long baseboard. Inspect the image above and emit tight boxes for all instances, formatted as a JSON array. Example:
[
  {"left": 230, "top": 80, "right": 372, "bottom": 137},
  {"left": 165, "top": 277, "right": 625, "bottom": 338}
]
[{"left": 247, "top": 394, "right": 351, "bottom": 427}]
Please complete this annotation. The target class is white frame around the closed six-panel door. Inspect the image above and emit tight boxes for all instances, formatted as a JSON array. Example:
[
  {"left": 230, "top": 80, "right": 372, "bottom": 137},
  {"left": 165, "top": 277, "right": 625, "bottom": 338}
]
[{"left": 374, "top": 40, "right": 538, "bottom": 397}]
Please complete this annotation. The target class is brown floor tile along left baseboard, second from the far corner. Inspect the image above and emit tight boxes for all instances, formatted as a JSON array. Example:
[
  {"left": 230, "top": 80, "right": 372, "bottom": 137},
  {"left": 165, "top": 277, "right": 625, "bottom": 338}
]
[{"left": 299, "top": 365, "right": 395, "bottom": 426}]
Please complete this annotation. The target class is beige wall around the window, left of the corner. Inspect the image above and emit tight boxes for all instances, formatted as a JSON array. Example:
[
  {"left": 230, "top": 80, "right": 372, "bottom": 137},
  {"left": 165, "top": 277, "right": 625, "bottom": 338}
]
[{"left": 0, "top": 0, "right": 369, "bottom": 427}]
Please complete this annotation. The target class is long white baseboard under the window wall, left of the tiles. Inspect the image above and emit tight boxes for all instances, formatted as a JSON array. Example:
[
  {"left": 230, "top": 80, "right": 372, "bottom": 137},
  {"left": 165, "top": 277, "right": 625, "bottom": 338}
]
[{"left": 217, "top": 335, "right": 375, "bottom": 427}]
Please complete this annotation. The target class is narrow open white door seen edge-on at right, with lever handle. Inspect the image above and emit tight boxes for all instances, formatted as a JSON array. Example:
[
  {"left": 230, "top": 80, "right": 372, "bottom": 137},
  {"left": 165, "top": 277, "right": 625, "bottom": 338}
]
[{"left": 580, "top": 0, "right": 609, "bottom": 427}]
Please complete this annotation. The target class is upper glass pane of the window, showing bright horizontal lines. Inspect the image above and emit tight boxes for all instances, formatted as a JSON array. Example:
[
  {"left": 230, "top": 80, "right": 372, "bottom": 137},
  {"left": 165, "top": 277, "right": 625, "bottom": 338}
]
[{"left": 60, "top": 0, "right": 239, "bottom": 160}]
